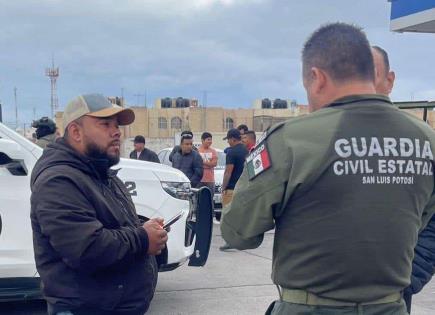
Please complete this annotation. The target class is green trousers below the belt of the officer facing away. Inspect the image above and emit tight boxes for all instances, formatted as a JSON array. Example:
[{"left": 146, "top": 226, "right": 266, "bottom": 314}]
[{"left": 270, "top": 300, "right": 408, "bottom": 315}]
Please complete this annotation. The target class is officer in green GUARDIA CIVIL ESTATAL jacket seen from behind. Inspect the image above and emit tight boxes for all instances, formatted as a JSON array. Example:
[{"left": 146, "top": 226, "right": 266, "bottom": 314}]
[{"left": 221, "top": 23, "right": 435, "bottom": 315}]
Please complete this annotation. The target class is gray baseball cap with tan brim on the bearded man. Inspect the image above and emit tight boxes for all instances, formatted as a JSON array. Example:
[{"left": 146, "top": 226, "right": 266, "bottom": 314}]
[{"left": 63, "top": 94, "right": 135, "bottom": 128}]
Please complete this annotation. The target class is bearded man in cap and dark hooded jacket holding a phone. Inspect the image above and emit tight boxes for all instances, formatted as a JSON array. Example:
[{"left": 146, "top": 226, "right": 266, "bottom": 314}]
[{"left": 30, "top": 94, "right": 168, "bottom": 315}]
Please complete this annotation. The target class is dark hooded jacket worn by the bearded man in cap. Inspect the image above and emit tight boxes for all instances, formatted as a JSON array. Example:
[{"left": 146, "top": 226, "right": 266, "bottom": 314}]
[{"left": 31, "top": 140, "right": 157, "bottom": 314}]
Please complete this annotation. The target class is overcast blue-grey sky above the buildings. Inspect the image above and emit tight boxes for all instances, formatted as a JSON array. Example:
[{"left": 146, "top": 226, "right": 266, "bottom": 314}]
[{"left": 0, "top": 0, "right": 435, "bottom": 123}]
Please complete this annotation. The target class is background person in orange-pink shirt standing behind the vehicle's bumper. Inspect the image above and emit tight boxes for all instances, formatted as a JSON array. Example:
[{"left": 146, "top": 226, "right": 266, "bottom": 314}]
[{"left": 198, "top": 132, "right": 218, "bottom": 197}]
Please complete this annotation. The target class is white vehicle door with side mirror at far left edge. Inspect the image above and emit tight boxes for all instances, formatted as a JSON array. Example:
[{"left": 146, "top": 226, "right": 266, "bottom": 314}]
[{"left": 0, "top": 139, "right": 36, "bottom": 278}]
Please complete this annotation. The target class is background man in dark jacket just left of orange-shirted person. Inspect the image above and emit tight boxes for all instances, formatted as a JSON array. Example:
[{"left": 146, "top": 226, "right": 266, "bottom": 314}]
[{"left": 172, "top": 134, "right": 204, "bottom": 187}]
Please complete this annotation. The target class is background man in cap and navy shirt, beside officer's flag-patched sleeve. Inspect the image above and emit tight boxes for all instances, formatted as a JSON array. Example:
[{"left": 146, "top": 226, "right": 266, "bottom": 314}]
[{"left": 219, "top": 129, "right": 248, "bottom": 251}]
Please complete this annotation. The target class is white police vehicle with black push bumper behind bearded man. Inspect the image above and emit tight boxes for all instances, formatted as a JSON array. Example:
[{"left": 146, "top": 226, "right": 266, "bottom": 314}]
[{"left": 0, "top": 123, "right": 213, "bottom": 301}]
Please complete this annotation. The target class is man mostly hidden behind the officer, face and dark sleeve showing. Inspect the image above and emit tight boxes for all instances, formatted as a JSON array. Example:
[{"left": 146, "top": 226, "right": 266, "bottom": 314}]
[{"left": 372, "top": 46, "right": 435, "bottom": 314}]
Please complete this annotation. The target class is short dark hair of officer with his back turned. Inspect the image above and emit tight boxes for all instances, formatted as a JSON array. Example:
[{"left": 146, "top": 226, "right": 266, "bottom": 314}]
[{"left": 302, "top": 23, "right": 375, "bottom": 82}]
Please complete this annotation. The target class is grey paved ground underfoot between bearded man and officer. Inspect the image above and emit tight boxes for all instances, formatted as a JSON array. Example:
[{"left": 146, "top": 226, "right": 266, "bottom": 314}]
[{"left": 0, "top": 225, "right": 435, "bottom": 315}]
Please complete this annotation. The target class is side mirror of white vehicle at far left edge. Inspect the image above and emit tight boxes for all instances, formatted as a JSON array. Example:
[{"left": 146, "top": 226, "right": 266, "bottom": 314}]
[{"left": 0, "top": 139, "right": 28, "bottom": 176}]
